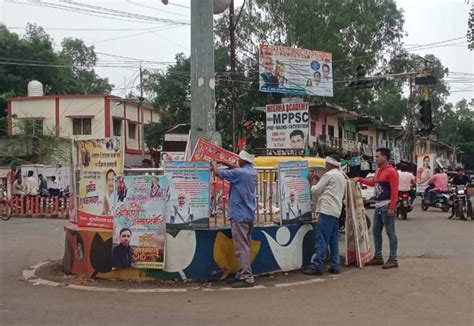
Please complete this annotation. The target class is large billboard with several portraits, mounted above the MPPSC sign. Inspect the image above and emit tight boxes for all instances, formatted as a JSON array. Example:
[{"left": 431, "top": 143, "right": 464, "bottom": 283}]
[{"left": 259, "top": 44, "right": 333, "bottom": 97}]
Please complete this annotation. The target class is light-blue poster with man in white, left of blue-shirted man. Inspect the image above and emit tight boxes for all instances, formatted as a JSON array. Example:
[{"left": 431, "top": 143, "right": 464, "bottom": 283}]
[{"left": 165, "top": 161, "right": 210, "bottom": 228}]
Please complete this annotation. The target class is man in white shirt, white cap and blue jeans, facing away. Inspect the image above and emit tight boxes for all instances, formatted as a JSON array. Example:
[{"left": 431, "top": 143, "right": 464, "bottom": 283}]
[{"left": 303, "top": 156, "right": 347, "bottom": 275}]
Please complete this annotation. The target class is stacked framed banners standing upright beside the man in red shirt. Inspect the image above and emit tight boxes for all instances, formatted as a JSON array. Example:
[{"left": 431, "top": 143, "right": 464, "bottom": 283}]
[{"left": 345, "top": 181, "right": 372, "bottom": 268}]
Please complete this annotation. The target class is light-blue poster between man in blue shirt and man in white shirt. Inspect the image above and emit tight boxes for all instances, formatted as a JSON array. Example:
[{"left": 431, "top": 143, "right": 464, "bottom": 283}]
[{"left": 278, "top": 161, "right": 311, "bottom": 224}]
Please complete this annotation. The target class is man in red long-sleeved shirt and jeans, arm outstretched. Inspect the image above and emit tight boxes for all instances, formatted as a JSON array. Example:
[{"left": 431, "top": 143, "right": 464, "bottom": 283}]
[{"left": 354, "top": 148, "right": 398, "bottom": 269}]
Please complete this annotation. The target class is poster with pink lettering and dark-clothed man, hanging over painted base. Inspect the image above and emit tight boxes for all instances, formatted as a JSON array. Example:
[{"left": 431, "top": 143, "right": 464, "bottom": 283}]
[{"left": 112, "top": 175, "right": 167, "bottom": 269}]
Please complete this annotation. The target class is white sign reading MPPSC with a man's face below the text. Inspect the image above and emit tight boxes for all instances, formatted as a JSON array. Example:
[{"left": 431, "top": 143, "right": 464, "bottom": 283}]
[{"left": 265, "top": 102, "right": 309, "bottom": 149}]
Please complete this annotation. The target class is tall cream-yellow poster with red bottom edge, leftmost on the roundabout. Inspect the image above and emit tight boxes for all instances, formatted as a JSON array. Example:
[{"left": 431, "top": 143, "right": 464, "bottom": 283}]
[{"left": 76, "top": 138, "right": 123, "bottom": 229}]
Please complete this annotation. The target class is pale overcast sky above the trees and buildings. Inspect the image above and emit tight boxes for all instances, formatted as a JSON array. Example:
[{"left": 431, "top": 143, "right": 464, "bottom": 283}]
[{"left": 0, "top": 0, "right": 474, "bottom": 103}]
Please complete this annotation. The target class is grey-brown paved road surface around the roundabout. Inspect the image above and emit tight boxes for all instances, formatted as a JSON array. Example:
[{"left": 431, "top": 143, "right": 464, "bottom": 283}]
[{"left": 0, "top": 207, "right": 474, "bottom": 326}]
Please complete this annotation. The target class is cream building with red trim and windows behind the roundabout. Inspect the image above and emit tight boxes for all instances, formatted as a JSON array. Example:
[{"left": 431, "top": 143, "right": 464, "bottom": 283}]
[{"left": 7, "top": 94, "right": 159, "bottom": 166}]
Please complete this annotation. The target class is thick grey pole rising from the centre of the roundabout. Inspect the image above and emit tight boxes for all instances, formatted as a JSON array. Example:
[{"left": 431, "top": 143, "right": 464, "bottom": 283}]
[{"left": 191, "top": 0, "right": 221, "bottom": 148}]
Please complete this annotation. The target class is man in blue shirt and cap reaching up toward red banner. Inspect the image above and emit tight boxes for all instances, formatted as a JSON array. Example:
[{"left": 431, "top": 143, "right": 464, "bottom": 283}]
[{"left": 213, "top": 151, "right": 257, "bottom": 288}]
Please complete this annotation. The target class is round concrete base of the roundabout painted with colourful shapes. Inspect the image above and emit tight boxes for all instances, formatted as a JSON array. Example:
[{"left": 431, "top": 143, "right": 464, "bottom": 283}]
[{"left": 63, "top": 223, "right": 314, "bottom": 281}]
